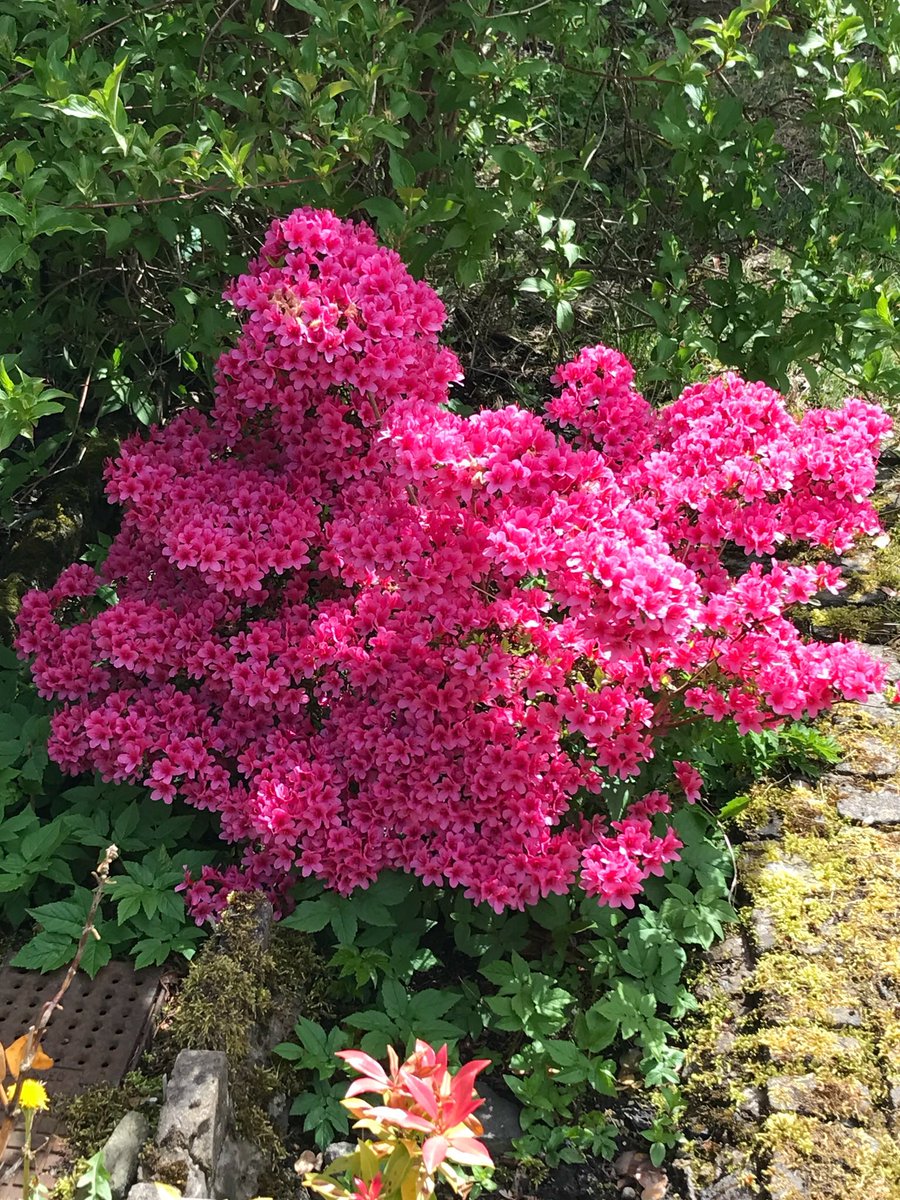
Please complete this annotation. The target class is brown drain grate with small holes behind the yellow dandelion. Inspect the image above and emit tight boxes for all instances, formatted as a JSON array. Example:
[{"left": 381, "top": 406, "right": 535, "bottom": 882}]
[{"left": 0, "top": 962, "right": 162, "bottom": 1200}]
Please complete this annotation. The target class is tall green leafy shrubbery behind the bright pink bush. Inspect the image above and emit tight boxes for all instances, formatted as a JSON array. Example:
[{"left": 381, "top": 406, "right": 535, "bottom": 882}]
[{"left": 0, "top": 0, "right": 900, "bottom": 535}]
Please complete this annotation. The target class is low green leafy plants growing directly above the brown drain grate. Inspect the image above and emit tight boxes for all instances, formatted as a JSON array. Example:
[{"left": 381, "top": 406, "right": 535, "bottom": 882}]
[{"left": 0, "top": 647, "right": 211, "bottom": 976}]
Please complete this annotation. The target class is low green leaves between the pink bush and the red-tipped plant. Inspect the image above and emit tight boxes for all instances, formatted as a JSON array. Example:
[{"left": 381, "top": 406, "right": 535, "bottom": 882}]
[{"left": 276, "top": 796, "right": 734, "bottom": 1162}]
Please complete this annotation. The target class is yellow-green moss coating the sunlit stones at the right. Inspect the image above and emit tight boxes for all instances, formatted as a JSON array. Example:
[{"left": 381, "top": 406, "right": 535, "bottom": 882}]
[{"left": 685, "top": 739, "right": 900, "bottom": 1200}]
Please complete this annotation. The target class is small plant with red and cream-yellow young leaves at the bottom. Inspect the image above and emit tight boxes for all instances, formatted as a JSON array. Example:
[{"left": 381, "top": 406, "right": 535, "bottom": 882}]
[{"left": 304, "top": 1039, "right": 493, "bottom": 1200}]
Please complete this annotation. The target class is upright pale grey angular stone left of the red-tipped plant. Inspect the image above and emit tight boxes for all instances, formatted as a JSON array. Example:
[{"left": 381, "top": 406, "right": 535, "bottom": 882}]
[{"left": 156, "top": 1050, "right": 229, "bottom": 1176}]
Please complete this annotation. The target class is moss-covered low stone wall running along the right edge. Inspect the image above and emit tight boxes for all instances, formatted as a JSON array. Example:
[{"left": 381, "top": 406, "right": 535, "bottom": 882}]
[{"left": 682, "top": 647, "right": 900, "bottom": 1200}]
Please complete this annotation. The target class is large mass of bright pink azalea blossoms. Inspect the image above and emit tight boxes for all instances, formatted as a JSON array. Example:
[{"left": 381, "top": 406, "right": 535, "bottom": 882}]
[{"left": 17, "top": 210, "right": 889, "bottom": 919}]
